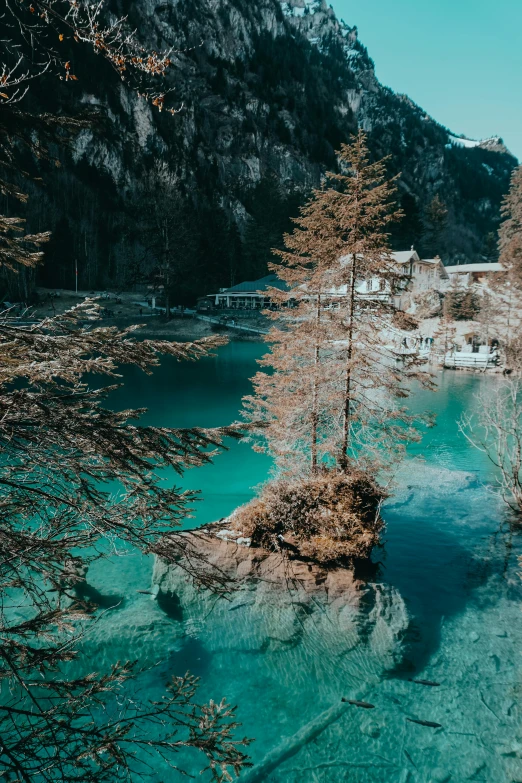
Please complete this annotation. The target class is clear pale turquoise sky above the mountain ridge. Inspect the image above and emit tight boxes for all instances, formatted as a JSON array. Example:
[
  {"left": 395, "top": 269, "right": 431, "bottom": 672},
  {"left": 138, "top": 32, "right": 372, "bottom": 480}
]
[{"left": 329, "top": 0, "right": 522, "bottom": 161}]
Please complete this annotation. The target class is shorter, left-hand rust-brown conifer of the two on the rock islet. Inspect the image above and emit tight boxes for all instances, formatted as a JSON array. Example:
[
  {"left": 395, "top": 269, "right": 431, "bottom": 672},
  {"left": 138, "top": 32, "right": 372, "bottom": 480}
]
[{"left": 246, "top": 182, "right": 338, "bottom": 476}]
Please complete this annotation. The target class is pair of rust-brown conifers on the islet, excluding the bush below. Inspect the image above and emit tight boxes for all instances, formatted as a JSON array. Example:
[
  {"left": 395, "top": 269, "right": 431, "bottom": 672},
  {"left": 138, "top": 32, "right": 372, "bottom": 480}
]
[{"left": 246, "top": 131, "right": 430, "bottom": 475}]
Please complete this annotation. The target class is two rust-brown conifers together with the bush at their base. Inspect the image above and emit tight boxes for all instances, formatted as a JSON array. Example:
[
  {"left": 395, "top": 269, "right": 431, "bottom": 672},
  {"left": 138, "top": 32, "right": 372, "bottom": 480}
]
[{"left": 240, "top": 131, "right": 431, "bottom": 559}]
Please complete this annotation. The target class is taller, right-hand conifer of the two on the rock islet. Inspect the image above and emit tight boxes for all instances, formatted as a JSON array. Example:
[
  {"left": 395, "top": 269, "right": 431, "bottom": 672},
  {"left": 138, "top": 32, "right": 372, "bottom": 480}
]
[{"left": 330, "top": 138, "right": 430, "bottom": 473}]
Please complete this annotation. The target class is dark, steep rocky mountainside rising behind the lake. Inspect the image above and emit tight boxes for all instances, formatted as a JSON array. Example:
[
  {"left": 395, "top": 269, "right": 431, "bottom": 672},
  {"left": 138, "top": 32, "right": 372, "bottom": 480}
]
[{"left": 20, "top": 0, "right": 516, "bottom": 301}]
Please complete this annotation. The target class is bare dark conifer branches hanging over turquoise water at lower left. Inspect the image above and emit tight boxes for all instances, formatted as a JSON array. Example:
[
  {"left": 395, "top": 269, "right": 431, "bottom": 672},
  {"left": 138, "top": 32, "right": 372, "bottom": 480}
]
[{"left": 0, "top": 302, "right": 252, "bottom": 781}]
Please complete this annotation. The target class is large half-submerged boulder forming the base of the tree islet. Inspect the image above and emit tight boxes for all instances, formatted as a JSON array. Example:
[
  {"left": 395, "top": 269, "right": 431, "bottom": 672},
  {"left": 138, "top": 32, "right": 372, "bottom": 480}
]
[{"left": 153, "top": 523, "right": 409, "bottom": 672}]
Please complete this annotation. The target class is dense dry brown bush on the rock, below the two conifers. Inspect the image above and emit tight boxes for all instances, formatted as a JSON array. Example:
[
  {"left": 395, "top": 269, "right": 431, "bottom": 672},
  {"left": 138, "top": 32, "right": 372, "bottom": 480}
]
[{"left": 234, "top": 470, "right": 385, "bottom": 563}]
